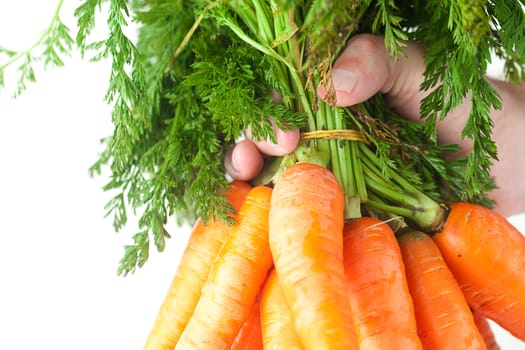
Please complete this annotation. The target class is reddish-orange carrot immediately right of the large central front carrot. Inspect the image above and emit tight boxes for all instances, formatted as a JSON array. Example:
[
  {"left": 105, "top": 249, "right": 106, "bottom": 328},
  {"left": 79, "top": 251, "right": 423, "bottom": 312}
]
[{"left": 343, "top": 217, "right": 422, "bottom": 350}]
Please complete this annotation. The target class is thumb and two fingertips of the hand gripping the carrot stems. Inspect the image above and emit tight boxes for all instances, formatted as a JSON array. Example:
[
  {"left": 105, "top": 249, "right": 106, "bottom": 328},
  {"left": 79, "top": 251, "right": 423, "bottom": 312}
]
[{"left": 225, "top": 34, "right": 452, "bottom": 180}]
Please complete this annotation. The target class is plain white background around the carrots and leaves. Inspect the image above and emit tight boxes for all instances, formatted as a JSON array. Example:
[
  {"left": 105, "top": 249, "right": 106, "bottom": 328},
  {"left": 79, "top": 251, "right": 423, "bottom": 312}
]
[{"left": 0, "top": 0, "right": 525, "bottom": 350}]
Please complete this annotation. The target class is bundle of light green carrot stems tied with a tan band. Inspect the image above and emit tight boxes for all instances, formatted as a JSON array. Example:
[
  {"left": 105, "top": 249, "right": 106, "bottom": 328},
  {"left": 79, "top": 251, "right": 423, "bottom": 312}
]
[{"left": 221, "top": 0, "right": 445, "bottom": 232}]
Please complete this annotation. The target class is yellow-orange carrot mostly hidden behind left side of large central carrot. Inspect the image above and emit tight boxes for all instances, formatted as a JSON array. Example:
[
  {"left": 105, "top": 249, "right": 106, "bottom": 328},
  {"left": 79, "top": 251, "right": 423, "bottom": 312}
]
[{"left": 261, "top": 270, "right": 303, "bottom": 350}]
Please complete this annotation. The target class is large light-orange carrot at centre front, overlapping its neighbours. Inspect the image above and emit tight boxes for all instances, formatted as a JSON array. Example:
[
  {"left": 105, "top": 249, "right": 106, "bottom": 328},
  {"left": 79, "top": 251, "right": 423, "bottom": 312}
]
[{"left": 269, "top": 163, "right": 356, "bottom": 350}]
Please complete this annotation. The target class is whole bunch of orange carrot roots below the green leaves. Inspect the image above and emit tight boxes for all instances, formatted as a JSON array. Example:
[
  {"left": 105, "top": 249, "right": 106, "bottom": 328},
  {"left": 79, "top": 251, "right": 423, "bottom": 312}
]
[{"left": 144, "top": 162, "right": 525, "bottom": 350}]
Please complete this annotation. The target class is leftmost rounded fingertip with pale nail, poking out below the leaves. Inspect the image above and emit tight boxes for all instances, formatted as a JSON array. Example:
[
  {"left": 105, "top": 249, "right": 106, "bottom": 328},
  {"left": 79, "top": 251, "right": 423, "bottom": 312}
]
[{"left": 224, "top": 140, "right": 263, "bottom": 181}]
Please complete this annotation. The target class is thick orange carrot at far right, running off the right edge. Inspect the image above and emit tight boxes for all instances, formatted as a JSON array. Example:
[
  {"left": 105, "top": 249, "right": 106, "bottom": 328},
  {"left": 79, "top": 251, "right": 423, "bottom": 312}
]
[{"left": 433, "top": 203, "right": 525, "bottom": 340}]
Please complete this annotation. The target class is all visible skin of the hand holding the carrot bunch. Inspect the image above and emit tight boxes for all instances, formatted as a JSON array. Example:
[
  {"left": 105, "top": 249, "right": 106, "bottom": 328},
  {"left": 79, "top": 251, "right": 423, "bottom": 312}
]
[{"left": 224, "top": 34, "right": 525, "bottom": 216}]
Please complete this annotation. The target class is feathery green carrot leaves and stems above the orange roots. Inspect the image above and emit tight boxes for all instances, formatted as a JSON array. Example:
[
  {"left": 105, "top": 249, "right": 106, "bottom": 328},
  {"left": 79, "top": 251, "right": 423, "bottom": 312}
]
[{"left": 0, "top": 0, "right": 525, "bottom": 275}]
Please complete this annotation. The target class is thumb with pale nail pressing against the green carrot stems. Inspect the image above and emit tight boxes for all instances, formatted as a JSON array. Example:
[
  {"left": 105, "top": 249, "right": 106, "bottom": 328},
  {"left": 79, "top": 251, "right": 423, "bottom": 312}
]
[{"left": 318, "top": 34, "right": 425, "bottom": 123}]
